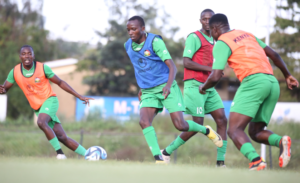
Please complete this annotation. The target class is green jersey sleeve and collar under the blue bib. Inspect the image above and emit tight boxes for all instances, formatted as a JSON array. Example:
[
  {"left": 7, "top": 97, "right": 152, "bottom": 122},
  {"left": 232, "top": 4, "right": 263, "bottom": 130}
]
[{"left": 124, "top": 34, "right": 172, "bottom": 61}]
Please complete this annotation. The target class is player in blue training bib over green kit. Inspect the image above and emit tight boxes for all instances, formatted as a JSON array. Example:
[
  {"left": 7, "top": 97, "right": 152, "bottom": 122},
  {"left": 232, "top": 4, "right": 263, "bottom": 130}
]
[{"left": 124, "top": 16, "right": 222, "bottom": 163}]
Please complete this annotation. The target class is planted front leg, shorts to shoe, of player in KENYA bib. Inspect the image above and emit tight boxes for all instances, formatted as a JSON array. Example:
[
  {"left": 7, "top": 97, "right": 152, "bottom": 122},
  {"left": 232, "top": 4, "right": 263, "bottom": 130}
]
[{"left": 228, "top": 74, "right": 272, "bottom": 170}]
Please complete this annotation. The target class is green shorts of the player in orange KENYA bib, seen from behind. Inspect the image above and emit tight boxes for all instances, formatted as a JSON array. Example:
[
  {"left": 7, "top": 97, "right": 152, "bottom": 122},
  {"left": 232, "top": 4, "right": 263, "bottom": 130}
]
[{"left": 230, "top": 73, "right": 280, "bottom": 125}]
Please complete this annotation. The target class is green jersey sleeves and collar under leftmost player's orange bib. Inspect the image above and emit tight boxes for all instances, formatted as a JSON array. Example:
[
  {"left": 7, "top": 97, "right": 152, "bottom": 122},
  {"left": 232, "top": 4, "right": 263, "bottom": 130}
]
[{"left": 6, "top": 62, "right": 55, "bottom": 84}]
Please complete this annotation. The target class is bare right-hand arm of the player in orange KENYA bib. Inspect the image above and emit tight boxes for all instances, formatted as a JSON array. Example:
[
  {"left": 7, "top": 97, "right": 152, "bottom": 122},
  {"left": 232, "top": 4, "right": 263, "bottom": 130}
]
[{"left": 264, "top": 46, "right": 299, "bottom": 90}]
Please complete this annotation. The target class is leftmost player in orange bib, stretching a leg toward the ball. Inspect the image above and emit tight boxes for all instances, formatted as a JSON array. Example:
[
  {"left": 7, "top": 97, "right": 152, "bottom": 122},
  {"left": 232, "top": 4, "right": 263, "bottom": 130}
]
[{"left": 0, "top": 45, "right": 91, "bottom": 159}]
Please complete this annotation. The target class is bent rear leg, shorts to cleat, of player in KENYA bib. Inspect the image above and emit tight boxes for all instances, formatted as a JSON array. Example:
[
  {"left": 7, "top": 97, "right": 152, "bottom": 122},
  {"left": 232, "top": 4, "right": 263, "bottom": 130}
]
[{"left": 248, "top": 76, "right": 292, "bottom": 167}]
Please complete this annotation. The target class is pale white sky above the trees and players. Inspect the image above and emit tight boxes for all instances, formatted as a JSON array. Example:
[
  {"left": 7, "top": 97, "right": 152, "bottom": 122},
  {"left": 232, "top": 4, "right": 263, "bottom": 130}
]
[{"left": 21, "top": 0, "right": 276, "bottom": 44}]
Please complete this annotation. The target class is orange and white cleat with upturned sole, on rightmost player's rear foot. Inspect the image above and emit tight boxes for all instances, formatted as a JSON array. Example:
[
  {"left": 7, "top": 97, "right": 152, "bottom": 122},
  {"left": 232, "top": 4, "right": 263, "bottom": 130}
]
[{"left": 279, "top": 136, "right": 292, "bottom": 168}]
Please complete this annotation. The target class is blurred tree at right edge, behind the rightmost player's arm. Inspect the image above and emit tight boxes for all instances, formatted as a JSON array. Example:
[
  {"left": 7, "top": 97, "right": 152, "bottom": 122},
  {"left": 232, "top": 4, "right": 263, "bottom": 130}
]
[{"left": 270, "top": 0, "right": 300, "bottom": 101}]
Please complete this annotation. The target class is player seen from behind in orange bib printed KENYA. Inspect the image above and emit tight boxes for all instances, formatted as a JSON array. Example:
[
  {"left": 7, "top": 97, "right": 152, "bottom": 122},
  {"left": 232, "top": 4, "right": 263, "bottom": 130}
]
[{"left": 199, "top": 14, "right": 299, "bottom": 170}]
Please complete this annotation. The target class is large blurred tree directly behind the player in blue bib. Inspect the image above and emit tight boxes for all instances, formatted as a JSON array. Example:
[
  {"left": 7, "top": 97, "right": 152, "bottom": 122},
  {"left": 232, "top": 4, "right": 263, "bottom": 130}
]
[{"left": 78, "top": 0, "right": 184, "bottom": 96}]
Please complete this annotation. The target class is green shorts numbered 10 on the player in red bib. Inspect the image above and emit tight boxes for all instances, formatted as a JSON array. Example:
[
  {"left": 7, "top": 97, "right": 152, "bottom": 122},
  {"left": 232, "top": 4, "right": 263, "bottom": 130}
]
[{"left": 184, "top": 80, "right": 224, "bottom": 117}]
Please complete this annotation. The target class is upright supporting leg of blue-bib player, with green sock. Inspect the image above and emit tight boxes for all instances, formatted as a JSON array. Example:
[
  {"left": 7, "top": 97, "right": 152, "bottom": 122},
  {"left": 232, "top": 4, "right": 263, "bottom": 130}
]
[{"left": 140, "top": 107, "right": 163, "bottom": 163}]
